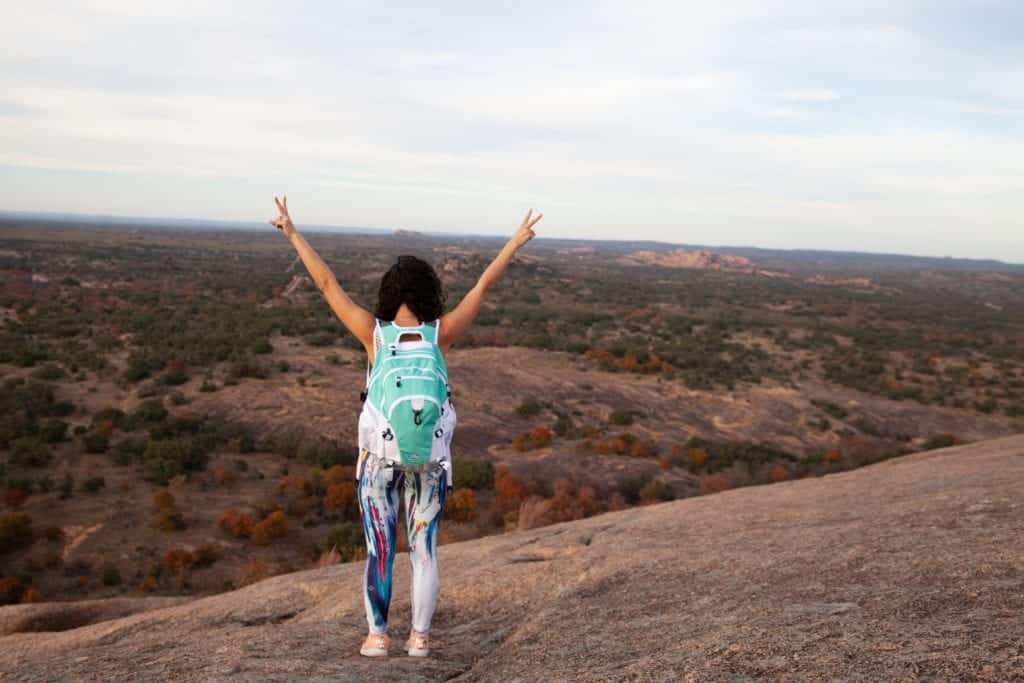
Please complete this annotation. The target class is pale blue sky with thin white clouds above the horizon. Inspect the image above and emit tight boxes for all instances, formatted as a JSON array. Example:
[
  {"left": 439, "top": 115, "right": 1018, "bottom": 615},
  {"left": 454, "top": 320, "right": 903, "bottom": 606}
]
[{"left": 0, "top": 0, "right": 1024, "bottom": 263}]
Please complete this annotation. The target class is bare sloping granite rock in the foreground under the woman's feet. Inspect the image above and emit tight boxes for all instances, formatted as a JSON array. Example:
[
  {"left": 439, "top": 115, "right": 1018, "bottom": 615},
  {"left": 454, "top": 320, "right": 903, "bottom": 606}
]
[{"left": 0, "top": 435, "right": 1024, "bottom": 681}]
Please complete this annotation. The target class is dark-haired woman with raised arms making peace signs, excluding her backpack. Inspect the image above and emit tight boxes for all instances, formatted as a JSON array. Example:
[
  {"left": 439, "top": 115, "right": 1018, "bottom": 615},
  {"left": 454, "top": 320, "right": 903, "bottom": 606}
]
[{"left": 270, "top": 197, "right": 542, "bottom": 656}]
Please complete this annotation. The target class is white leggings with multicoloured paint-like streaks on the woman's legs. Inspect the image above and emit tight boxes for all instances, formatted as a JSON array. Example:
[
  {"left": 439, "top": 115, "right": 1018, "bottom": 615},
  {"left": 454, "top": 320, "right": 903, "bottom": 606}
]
[{"left": 358, "top": 451, "right": 447, "bottom": 633}]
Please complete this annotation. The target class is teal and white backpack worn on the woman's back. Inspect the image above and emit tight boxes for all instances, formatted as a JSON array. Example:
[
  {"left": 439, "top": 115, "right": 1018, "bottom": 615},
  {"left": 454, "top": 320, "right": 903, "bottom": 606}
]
[{"left": 362, "top": 319, "right": 452, "bottom": 465}]
